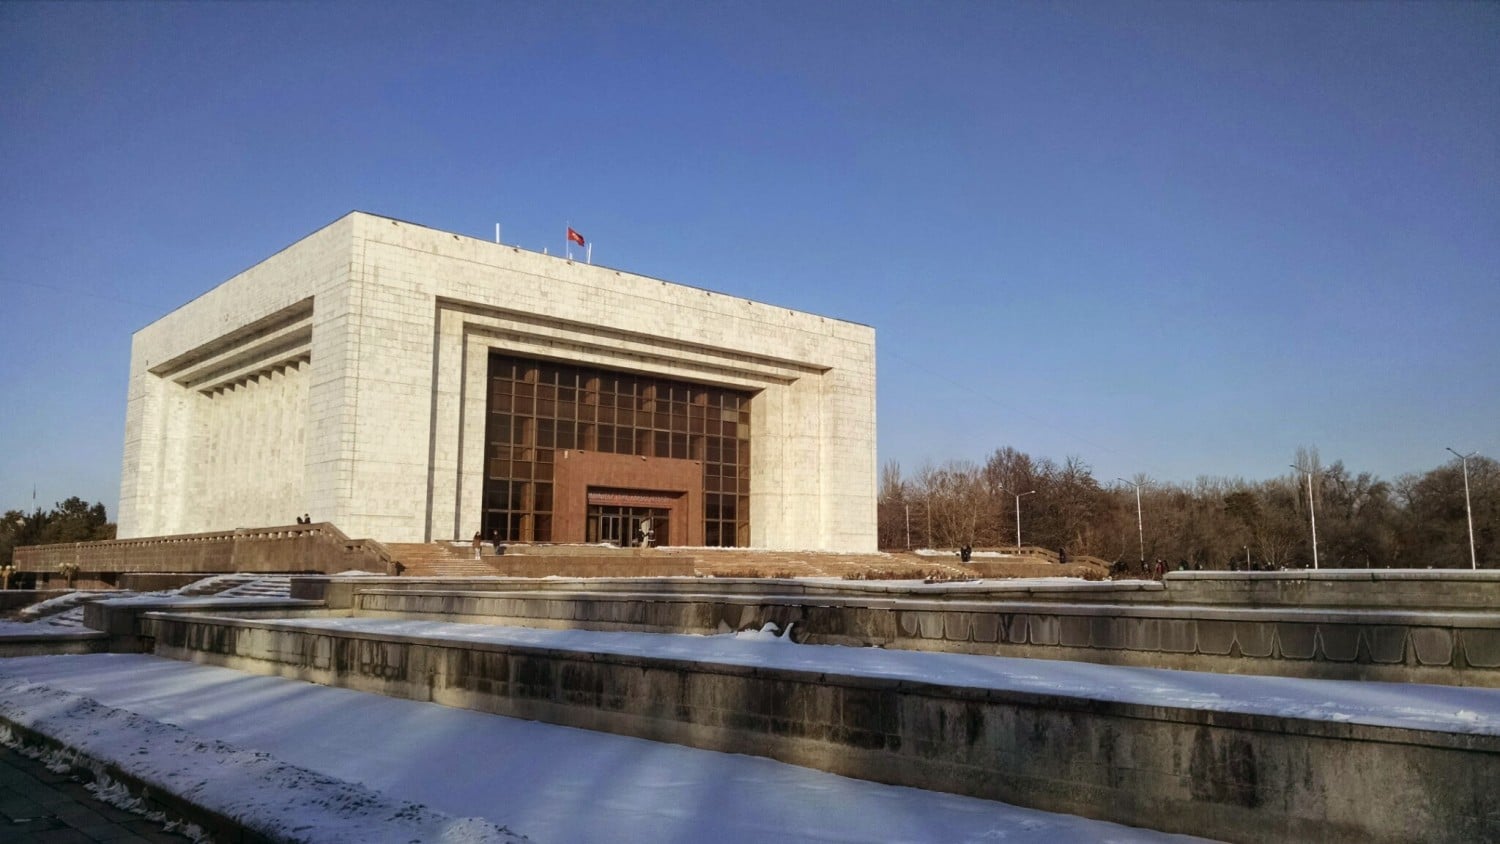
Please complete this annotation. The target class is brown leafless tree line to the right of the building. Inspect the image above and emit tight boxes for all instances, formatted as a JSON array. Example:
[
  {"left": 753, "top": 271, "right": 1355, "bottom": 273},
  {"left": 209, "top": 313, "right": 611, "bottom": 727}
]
[{"left": 879, "top": 447, "right": 1500, "bottom": 570}]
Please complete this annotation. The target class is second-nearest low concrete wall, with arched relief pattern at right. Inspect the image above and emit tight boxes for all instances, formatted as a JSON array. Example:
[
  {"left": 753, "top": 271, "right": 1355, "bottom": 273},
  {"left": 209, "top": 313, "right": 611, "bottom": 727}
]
[{"left": 351, "top": 586, "right": 1500, "bottom": 688}]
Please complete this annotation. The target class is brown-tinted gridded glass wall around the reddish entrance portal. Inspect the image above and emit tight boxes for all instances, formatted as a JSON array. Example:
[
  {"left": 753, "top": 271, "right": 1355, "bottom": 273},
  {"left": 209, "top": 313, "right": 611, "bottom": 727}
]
[{"left": 483, "top": 354, "right": 750, "bottom": 546}]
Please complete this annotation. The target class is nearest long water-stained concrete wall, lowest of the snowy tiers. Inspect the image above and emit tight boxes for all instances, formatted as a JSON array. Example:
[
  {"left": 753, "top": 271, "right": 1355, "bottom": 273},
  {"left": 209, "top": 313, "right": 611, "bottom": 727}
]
[{"left": 144, "top": 613, "right": 1500, "bottom": 844}]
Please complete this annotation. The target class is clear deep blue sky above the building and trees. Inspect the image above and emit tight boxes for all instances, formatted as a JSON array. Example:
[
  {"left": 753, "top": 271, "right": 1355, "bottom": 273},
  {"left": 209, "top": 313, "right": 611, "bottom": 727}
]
[{"left": 0, "top": 0, "right": 1500, "bottom": 516}]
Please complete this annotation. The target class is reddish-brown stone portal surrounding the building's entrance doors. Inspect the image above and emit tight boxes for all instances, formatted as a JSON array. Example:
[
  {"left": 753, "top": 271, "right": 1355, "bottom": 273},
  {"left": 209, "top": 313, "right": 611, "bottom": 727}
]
[{"left": 552, "top": 450, "right": 704, "bottom": 546}]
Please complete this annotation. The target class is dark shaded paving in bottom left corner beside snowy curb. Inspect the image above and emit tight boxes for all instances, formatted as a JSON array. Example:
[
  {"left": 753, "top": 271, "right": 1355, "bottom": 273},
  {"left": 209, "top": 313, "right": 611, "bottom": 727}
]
[{"left": 0, "top": 745, "right": 192, "bottom": 844}]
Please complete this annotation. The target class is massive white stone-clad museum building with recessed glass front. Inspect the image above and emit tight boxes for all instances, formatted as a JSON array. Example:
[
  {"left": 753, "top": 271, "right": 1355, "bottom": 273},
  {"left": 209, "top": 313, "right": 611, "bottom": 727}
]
[{"left": 119, "top": 213, "right": 876, "bottom": 550}]
